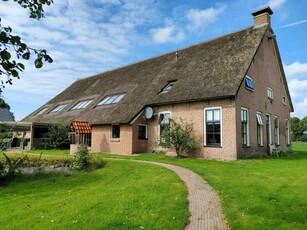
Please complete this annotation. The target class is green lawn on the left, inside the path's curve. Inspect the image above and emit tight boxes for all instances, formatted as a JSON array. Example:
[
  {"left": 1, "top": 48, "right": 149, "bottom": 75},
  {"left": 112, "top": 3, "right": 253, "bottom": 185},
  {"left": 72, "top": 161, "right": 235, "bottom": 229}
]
[{"left": 0, "top": 160, "right": 189, "bottom": 229}]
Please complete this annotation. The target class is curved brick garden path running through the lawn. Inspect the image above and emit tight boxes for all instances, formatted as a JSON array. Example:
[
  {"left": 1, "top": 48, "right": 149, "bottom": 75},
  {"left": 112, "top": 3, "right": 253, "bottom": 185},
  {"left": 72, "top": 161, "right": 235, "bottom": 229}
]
[{"left": 108, "top": 158, "right": 229, "bottom": 230}]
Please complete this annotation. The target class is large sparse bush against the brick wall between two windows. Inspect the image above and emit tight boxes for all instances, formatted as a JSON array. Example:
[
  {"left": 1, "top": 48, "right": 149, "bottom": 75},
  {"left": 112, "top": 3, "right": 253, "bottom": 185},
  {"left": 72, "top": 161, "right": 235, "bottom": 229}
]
[{"left": 161, "top": 119, "right": 200, "bottom": 157}]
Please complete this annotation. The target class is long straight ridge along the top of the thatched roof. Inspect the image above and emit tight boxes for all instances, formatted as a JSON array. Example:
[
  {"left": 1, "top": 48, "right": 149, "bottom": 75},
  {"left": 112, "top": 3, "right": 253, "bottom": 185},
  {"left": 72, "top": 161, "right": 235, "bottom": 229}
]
[{"left": 75, "top": 26, "right": 258, "bottom": 82}]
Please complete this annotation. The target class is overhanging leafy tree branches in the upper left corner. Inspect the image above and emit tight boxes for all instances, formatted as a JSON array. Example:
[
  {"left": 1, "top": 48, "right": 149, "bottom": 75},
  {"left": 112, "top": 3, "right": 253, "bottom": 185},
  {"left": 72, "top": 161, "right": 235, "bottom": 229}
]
[{"left": 0, "top": 0, "right": 53, "bottom": 90}]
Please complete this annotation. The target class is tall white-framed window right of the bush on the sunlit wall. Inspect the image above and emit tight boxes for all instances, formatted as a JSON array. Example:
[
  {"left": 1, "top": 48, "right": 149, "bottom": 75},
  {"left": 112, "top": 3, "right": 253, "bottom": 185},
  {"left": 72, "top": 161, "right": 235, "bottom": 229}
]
[{"left": 205, "top": 108, "right": 222, "bottom": 146}]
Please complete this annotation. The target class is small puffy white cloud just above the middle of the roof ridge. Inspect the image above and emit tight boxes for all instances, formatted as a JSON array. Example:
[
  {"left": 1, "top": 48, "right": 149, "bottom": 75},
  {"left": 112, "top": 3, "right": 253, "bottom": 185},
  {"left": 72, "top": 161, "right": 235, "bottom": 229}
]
[{"left": 150, "top": 25, "right": 184, "bottom": 43}]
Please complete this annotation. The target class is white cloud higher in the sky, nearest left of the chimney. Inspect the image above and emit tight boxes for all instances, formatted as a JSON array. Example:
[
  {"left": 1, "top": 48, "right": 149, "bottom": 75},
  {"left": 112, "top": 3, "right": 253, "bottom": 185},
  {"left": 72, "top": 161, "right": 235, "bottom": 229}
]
[{"left": 187, "top": 5, "right": 225, "bottom": 30}]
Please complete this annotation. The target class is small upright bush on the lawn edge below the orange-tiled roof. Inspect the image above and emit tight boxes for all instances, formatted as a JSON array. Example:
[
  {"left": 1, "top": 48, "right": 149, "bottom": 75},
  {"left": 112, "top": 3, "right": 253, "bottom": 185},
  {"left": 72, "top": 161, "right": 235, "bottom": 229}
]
[{"left": 72, "top": 145, "right": 91, "bottom": 171}]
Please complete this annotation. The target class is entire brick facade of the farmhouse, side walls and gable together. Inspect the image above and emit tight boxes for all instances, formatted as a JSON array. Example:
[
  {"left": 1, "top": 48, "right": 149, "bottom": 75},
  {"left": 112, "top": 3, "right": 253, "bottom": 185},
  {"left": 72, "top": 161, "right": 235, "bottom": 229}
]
[{"left": 92, "top": 29, "right": 291, "bottom": 160}]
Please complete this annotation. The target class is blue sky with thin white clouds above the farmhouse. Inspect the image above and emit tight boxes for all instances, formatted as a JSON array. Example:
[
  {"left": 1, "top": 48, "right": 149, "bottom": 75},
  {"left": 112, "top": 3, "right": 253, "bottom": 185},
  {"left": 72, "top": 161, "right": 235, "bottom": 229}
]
[{"left": 0, "top": 0, "right": 307, "bottom": 120}]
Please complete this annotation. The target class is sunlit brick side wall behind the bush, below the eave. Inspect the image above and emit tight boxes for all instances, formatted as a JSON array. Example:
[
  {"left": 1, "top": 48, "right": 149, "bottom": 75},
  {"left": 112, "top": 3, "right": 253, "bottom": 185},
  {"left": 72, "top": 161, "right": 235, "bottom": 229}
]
[{"left": 148, "top": 99, "right": 237, "bottom": 160}]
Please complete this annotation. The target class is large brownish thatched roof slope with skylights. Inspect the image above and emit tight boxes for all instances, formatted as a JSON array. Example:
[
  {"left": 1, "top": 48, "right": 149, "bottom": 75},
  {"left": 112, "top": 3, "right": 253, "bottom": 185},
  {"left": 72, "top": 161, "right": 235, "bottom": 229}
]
[{"left": 23, "top": 26, "right": 267, "bottom": 124}]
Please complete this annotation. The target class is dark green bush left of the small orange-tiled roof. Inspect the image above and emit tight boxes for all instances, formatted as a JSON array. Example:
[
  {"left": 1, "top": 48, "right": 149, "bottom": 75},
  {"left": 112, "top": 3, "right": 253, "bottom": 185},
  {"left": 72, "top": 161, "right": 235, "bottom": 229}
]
[{"left": 44, "top": 123, "right": 69, "bottom": 149}]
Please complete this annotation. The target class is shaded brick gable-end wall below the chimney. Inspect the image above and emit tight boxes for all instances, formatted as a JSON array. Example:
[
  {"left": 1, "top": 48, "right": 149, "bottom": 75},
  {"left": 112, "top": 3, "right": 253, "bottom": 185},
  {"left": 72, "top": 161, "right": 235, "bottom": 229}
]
[{"left": 236, "top": 29, "right": 291, "bottom": 156}]
